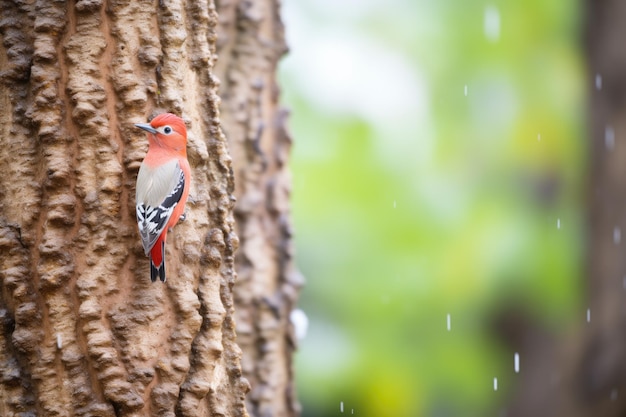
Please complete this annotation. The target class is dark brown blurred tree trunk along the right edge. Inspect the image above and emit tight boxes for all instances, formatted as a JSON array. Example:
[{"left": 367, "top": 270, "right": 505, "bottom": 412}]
[{"left": 575, "top": 0, "right": 626, "bottom": 417}]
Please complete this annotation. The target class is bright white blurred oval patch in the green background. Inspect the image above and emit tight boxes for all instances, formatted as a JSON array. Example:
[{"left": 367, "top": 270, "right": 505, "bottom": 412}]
[{"left": 283, "top": 28, "right": 427, "bottom": 125}]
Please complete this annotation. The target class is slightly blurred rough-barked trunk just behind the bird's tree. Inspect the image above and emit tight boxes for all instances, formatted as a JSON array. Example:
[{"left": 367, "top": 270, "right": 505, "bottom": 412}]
[{"left": 216, "top": 0, "right": 303, "bottom": 417}]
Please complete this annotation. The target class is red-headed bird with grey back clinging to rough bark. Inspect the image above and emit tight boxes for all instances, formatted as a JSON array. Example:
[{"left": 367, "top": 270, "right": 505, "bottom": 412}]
[{"left": 135, "top": 113, "right": 191, "bottom": 282}]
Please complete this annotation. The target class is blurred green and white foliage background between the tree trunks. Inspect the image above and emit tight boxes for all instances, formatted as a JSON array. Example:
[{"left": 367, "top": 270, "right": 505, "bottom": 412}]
[{"left": 280, "top": 0, "right": 584, "bottom": 417}]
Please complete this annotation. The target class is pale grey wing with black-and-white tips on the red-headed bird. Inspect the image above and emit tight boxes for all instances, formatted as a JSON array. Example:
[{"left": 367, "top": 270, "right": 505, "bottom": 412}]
[{"left": 136, "top": 160, "right": 186, "bottom": 255}]
